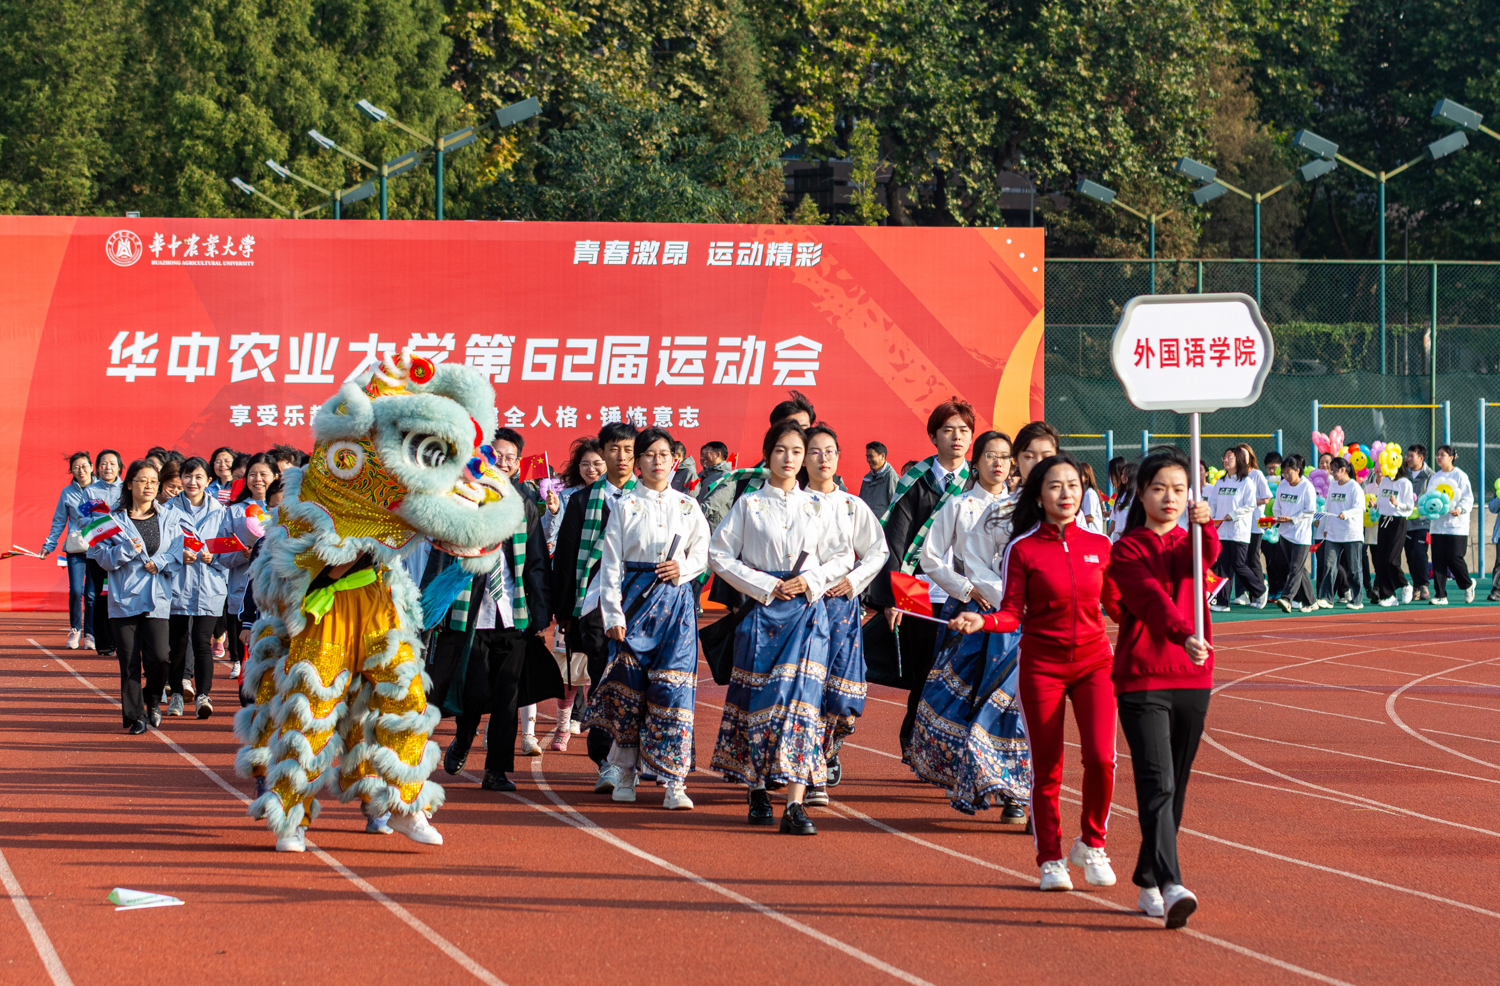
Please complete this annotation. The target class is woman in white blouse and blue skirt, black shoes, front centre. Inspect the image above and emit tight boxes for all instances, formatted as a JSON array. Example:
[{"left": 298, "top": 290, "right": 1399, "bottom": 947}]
[{"left": 708, "top": 420, "right": 854, "bottom": 836}]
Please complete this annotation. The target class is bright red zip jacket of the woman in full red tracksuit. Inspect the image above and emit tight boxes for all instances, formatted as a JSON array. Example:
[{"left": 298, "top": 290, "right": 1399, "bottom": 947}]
[{"left": 984, "top": 524, "right": 1110, "bottom": 662}]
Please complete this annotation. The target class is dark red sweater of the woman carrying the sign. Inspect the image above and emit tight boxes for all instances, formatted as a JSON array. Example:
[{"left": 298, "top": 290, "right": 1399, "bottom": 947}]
[{"left": 1104, "top": 524, "right": 1220, "bottom": 693}]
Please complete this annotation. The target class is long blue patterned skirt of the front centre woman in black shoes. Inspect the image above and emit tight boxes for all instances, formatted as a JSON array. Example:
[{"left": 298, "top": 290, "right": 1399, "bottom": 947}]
[{"left": 713, "top": 572, "right": 828, "bottom": 788}]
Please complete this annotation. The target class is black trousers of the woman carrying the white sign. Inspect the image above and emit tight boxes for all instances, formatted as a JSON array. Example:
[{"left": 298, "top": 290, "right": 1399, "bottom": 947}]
[{"left": 1119, "top": 689, "right": 1209, "bottom": 887}]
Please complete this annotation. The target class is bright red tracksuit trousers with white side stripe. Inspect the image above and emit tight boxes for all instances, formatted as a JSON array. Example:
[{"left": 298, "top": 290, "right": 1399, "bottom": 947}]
[{"left": 1020, "top": 642, "right": 1116, "bottom": 866}]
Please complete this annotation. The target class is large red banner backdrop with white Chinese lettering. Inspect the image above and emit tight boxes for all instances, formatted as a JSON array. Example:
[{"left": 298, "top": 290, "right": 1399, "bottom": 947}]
[{"left": 0, "top": 216, "right": 1043, "bottom": 609}]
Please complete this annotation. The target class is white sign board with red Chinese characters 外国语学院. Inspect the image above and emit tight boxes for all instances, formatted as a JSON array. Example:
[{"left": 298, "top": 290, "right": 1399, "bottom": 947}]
[{"left": 1110, "top": 294, "right": 1275, "bottom": 414}]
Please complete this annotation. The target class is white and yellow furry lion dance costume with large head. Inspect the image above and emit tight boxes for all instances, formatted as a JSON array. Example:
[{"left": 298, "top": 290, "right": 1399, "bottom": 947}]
[{"left": 234, "top": 354, "right": 524, "bottom": 851}]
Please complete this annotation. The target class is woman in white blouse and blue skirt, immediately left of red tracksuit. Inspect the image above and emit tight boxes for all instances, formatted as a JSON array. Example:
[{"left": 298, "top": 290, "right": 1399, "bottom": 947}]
[{"left": 909, "top": 431, "right": 1031, "bottom": 824}]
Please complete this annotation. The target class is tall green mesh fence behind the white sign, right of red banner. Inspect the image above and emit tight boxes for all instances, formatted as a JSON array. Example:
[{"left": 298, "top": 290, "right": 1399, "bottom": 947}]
[{"left": 1046, "top": 260, "right": 1500, "bottom": 573}]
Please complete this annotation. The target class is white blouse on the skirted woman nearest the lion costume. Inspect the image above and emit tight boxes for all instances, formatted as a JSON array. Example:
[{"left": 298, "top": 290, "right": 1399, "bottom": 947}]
[{"left": 594, "top": 485, "right": 710, "bottom": 630}]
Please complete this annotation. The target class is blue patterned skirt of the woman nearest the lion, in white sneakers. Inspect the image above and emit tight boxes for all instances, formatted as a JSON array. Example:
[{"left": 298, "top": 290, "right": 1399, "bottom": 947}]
[{"left": 584, "top": 561, "right": 698, "bottom": 780}]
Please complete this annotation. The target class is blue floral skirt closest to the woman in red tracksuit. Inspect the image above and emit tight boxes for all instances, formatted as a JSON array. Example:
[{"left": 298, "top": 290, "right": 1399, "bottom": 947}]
[{"left": 909, "top": 599, "right": 1032, "bottom": 815}]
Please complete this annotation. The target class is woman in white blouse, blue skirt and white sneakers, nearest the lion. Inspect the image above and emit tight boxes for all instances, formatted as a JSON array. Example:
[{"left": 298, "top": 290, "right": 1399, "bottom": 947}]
[{"left": 585, "top": 428, "right": 710, "bottom": 809}]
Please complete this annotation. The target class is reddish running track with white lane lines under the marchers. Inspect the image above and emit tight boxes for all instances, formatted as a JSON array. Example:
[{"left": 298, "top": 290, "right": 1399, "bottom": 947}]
[{"left": 0, "top": 606, "right": 1500, "bottom": 986}]
